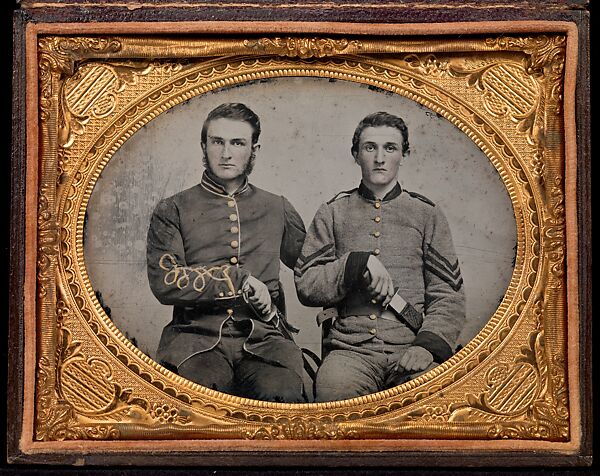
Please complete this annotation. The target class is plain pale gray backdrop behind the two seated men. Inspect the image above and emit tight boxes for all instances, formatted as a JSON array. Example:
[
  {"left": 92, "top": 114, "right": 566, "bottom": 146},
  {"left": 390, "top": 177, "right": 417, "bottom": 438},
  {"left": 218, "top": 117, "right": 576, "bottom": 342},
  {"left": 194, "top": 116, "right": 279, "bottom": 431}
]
[{"left": 84, "top": 78, "right": 516, "bottom": 358}]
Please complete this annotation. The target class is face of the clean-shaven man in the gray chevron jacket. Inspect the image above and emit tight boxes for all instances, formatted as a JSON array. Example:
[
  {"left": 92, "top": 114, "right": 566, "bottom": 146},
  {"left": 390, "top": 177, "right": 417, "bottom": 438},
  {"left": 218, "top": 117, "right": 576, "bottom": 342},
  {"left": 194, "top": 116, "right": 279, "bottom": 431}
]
[{"left": 354, "top": 126, "right": 403, "bottom": 188}]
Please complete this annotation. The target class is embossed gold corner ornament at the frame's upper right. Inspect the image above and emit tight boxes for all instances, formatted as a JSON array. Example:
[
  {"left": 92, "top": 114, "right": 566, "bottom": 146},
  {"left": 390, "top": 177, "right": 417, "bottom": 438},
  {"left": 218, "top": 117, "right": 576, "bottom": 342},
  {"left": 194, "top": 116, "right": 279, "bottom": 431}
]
[{"left": 404, "top": 35, "right": 566, "bottom": 188}]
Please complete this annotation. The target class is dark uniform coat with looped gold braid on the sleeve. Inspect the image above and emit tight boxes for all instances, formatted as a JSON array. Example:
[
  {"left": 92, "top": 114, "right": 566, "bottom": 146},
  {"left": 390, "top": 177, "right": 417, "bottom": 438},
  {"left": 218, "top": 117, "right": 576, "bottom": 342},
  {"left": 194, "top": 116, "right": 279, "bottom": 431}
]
[{"left": 147, "top": 172, "right": 305, "bottom": 372}]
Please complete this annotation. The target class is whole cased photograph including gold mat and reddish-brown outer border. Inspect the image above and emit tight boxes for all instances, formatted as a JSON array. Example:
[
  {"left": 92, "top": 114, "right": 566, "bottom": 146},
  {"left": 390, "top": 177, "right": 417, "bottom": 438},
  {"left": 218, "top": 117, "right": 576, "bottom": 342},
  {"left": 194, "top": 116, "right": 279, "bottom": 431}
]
[{"left": 11, "top": 13, "right": 587, "bottom": 465}]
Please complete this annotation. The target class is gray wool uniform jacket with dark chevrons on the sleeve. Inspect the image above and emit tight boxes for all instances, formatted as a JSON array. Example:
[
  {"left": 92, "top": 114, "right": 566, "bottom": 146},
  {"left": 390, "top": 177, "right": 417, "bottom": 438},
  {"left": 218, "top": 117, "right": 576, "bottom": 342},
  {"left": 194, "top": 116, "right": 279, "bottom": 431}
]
[{"left": 294, "top": 183, "right": 465, "bottom": 362}]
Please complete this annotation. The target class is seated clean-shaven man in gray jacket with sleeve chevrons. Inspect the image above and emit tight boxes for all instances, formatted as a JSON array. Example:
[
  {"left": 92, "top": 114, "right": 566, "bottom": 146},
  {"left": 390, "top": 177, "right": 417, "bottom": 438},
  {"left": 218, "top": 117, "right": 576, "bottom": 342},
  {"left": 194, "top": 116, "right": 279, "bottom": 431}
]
[{"left": 294, "top": 112, "right": 465, "bottom": 402}]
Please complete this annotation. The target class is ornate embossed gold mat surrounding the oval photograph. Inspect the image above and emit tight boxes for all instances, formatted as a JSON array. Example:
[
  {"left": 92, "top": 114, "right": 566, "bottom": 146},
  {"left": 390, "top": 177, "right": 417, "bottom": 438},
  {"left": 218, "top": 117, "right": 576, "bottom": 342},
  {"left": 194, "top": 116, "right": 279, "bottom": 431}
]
[{"left": 34, "top": 35, "right": 570, "bottom": 441}]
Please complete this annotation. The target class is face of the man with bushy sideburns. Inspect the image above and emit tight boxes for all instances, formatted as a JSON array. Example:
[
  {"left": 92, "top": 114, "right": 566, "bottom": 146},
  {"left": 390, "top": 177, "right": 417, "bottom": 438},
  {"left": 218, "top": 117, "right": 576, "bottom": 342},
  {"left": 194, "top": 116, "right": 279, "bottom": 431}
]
[{"left": 204, "top": 118, "right": 259, "bottom": 185}]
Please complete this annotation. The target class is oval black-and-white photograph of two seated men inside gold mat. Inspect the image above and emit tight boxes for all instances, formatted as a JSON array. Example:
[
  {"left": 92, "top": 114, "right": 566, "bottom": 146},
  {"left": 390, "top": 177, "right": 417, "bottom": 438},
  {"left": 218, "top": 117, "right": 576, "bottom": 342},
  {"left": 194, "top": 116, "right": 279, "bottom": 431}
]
[{"left": 84, "top": 78, "right": 516, "bottom": 403}]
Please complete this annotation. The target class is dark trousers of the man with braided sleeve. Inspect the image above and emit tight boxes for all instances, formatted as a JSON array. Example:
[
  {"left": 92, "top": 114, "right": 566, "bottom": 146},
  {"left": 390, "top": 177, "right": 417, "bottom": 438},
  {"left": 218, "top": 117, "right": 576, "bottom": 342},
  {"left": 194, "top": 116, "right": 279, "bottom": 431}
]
[{"left": 177, "top": 321, "right": 306, "bottom": 403}]
